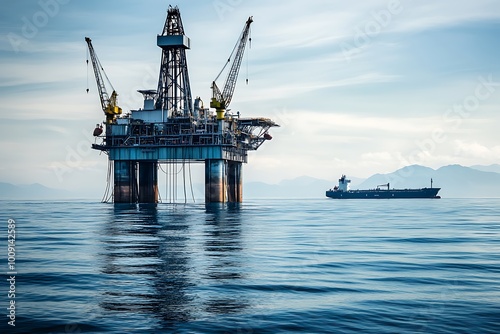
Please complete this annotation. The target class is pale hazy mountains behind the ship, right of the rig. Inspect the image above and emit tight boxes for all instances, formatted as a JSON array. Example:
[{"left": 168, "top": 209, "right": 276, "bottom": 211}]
[{"left": 243, "top": 165, "right": 500, "bottom": 198}]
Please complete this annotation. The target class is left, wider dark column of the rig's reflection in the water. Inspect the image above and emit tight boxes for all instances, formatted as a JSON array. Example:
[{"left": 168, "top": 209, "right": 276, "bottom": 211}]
[{"left": 100, "top": 204, "right": 191, "bottom": 322}]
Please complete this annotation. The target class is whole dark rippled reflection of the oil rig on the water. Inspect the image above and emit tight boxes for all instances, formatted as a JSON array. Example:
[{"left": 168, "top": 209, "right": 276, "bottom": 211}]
[{"left": 99, "top": 204, "right": 249, "bottom": 328}]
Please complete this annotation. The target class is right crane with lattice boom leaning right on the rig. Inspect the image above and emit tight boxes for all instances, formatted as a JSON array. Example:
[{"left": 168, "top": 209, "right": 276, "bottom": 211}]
[{"left": 210, "top": 16, "right": 253, "bottom": 120}]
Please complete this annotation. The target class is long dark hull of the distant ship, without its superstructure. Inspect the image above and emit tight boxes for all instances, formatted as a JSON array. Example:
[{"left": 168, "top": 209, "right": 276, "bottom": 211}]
[{"left": 326, "top": 188, "right": 441, "bottom": 199}]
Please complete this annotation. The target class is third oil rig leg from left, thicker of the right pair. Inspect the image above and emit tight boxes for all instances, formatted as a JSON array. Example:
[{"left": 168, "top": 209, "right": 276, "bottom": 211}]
[{"left": 205, "top": 159, "right": 227, "bottom": 203}]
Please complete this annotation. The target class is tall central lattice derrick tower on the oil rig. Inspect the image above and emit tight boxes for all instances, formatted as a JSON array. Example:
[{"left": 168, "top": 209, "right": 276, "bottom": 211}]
[{"left": 155, "top": 6, "right": 193, "bottom": 117}]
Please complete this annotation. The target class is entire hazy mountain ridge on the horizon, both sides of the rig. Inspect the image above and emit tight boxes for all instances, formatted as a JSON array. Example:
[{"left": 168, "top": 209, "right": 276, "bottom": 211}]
[{"left": 0, "top": 164, "right": 500, "bottom": 200}]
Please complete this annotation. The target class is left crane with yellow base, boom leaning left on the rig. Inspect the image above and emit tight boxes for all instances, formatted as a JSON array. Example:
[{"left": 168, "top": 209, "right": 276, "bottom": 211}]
[{"left": 85, "top": 37, "right": 122, "bottom": 124}]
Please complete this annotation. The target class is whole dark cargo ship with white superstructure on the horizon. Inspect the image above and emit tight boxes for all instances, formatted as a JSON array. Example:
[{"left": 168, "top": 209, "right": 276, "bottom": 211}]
[{"left": 326, "top": 175, "right": 441, "bottom": 199}]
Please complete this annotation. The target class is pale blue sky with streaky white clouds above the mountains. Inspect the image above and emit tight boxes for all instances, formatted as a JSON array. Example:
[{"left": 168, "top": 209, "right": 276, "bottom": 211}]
[{"left": 0, "top": 0, "right": 500, "bottom": 197}]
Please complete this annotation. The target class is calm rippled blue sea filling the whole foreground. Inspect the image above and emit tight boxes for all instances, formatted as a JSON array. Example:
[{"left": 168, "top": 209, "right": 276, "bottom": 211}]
[{"left": 0, "top": 199, "right": 500, "bottom": 334}]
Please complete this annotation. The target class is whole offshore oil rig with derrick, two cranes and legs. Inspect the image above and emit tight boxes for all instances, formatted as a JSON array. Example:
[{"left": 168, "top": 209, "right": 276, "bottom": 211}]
[{"left": 85, "top": 6, "right": 279, "bottom": 203}]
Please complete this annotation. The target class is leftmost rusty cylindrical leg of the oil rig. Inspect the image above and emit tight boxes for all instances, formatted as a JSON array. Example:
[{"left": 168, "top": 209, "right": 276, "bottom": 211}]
[{"left": 113, "top": 160, "right": 137, "bottom": 203}]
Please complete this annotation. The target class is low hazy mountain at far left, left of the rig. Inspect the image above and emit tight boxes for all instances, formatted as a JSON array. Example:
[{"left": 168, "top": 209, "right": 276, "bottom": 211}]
[{"left": 0, "top": 182, "right": 70, "bottom": 200}]
